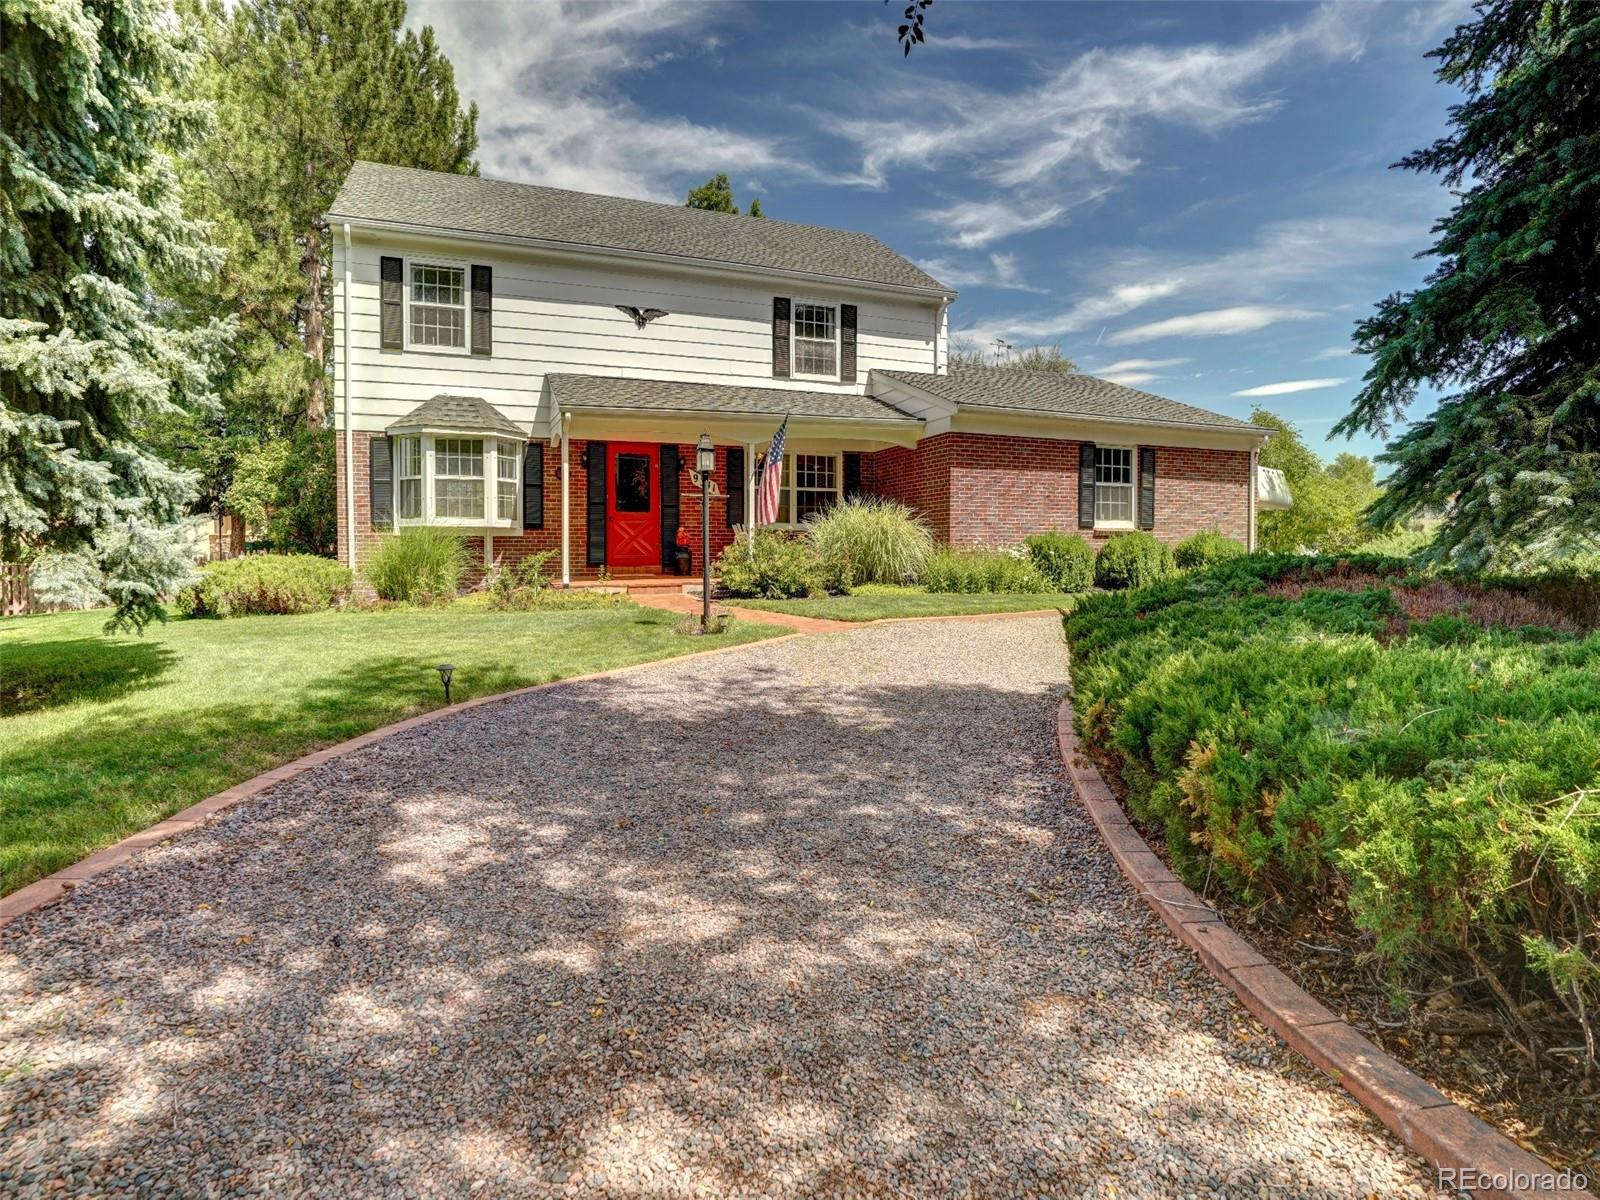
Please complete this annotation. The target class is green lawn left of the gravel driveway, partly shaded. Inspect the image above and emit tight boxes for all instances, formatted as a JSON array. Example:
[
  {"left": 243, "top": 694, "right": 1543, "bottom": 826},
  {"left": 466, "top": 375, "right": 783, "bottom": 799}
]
[{"left": 0, "top": 605, "right": 784, "bottom": 893}]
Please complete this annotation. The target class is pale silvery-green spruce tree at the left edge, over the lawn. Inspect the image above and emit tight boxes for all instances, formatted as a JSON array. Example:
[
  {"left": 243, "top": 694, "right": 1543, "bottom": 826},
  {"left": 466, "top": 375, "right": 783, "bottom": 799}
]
[{"left": 0, "top": 0, "right": 227, "bottom": 627}]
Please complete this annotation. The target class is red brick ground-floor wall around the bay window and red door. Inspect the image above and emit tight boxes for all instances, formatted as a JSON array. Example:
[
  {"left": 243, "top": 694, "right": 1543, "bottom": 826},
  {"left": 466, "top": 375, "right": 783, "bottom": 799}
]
[{"left": 338, "top": 434, "right": 742, "bottom": 584}]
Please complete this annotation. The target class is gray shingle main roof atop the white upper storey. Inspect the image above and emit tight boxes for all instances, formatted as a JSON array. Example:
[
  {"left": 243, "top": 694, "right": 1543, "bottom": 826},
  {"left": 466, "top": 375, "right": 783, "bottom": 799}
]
[{"left": 330, "top": 162, "right": 946, "bottom": 291}]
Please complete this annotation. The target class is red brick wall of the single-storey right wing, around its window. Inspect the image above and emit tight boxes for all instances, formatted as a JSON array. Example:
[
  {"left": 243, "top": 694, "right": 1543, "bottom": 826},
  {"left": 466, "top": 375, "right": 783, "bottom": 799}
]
[{"left": 862, "top": 434, "right": 1250, "bottom": 546}]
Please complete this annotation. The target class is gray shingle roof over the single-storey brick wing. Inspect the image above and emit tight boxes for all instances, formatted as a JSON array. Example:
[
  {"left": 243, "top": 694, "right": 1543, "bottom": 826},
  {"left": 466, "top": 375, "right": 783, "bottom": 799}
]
[{"left": 874, "top": 366, "right": 1267, "bottom": 434}]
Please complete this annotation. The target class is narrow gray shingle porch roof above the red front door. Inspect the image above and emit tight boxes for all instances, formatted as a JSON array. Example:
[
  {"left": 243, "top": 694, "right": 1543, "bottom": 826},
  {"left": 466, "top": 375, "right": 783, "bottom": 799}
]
[{"left": 544, "top": 374, "right": 918, "bottom": 424}]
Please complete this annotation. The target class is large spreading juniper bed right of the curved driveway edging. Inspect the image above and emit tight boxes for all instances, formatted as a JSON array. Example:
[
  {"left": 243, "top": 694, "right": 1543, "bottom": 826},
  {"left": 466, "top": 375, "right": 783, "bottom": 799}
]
[{"left": 1066, "top": 555, "right": 1600, "bottom": 1049}]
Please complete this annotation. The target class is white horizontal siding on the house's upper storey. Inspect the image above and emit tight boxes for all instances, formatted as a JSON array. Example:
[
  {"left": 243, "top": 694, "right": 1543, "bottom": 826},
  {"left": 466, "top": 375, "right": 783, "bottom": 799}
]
[{"left": 333, "top": 232, "right": 942, "bottom": 430}]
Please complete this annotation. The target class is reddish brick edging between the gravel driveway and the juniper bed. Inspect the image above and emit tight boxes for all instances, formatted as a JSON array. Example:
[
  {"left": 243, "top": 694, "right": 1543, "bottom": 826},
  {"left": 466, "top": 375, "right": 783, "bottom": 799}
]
[{"left": 1056, "top": 698, "right": 1594, "bottom": 1200}]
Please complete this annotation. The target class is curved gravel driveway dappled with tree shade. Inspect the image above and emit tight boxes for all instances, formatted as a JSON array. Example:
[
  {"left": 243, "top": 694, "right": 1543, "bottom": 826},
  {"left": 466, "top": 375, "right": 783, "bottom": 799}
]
[{"left": 0, "top": 619, "right": 1429, "bottom": 1200}]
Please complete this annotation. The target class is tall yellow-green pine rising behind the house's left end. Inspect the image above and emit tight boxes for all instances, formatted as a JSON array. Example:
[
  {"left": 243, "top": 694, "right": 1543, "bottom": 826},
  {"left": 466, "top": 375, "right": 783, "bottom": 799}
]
[{"left": 186, "top": 0, "right": 478, "bottom": 432}]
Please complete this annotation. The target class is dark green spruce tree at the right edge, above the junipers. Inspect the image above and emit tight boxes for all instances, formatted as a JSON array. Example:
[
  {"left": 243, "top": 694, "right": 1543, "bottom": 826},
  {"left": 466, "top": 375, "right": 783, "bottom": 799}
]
[{"left": 1336, "top": 0, "right": 1600, "bottom": 565}]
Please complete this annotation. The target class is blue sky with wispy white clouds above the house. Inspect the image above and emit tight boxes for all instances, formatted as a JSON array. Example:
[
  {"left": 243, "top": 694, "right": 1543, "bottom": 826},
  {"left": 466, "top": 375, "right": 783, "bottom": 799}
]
[{"left": 411, "top": 0, "right": 1467, "bottom": 458}]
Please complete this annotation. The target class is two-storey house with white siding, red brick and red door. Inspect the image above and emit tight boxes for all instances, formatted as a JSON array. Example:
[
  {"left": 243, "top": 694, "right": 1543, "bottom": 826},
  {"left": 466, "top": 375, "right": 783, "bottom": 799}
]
[{"left": 328, "top": 163, "right": 1266, "bottom": 582}]
